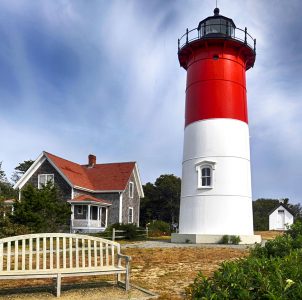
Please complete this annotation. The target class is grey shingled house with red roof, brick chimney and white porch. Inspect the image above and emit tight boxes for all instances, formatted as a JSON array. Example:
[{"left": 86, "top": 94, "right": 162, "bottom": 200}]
[{"left": 14, "top": 151, "right": 144, "bottom": 232}]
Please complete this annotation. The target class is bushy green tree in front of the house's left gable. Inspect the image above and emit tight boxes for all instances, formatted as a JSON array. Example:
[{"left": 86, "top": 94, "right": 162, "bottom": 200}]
[{"left": 11, "top": 183, "right": 71, "bottom": 232}]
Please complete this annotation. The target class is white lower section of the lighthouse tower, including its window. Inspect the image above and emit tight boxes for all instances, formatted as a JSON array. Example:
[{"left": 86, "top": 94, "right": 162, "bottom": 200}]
[{"left": 179, "top": 119, "right": 253, "bottom": 235}]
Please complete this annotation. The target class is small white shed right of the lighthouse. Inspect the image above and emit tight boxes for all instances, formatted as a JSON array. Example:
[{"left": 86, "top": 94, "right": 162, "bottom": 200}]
[{"left": 269, "top": 203, "right": 294, "bottom": 230}]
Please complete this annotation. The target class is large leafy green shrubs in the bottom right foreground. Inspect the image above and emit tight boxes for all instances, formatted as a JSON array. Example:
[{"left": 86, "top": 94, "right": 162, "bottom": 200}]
[{"left": 187, "top": 250, "right": 302, "bottom": 299}]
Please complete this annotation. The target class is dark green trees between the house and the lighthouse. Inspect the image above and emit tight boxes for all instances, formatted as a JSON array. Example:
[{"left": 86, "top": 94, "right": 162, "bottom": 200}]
[{"left": 140, "top": 174, "right": 181, "bottom": 224}]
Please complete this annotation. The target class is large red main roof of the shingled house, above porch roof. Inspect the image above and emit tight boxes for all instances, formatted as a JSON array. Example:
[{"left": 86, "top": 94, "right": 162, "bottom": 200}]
[{"left": 44, "top": 152, "right": 135, "bottom": 191}]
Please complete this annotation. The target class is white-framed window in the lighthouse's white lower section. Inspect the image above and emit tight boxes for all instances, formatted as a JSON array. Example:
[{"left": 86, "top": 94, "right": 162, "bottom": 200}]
[{"left": 196, "top": 161, "right": 216, "bottom": 189}]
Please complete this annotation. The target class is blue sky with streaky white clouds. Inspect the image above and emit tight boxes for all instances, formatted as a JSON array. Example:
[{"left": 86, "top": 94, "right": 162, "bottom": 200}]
[{"left": 0, "top": 0, "right": 302, "bottom": 202}]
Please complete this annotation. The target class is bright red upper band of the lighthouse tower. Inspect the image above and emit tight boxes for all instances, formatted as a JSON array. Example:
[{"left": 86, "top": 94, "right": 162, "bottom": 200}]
[{"left": 185, "top": 47, "right": 248, "bottom": 126}]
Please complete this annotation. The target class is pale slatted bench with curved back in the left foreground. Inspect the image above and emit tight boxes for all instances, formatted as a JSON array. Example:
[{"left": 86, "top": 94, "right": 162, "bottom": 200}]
[{"left": 0, "top": 233, "right": 131, "bottom": 297}]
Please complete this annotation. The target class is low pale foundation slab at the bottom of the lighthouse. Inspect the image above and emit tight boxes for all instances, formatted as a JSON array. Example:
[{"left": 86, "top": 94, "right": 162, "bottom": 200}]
[{"left": 171, "top": 233, "right": 261, "bottom": 245}]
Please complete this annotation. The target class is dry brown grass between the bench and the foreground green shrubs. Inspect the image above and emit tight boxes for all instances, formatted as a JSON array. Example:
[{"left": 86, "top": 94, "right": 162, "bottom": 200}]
[{"left": 123, "top": 247, "right": 248, "bottom": 299}]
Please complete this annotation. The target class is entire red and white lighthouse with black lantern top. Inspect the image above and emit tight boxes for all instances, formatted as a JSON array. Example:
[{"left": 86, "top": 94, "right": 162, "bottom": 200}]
[{"left": 172, "top": 7, "right": 261, "bottom": 244}]
